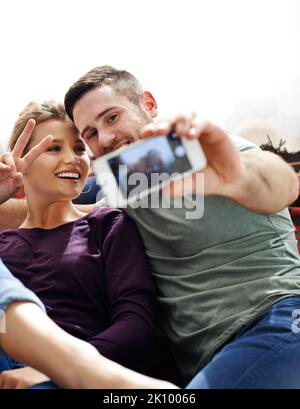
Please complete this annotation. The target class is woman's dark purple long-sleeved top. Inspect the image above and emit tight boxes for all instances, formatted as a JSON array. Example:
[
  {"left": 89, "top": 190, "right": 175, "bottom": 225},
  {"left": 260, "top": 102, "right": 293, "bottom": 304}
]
[{"left": 0, "top": 209, "right": 155, "bottom": 367}]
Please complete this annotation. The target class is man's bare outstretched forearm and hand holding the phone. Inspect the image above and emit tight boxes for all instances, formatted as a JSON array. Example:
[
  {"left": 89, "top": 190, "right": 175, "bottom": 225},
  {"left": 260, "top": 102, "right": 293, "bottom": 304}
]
[{"left": 141, "top": 116, "right": 299, "bottom": 214}]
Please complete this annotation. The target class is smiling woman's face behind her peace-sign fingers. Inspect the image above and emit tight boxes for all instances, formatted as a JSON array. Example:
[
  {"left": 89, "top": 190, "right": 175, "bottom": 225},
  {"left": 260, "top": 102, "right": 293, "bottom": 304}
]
[{"left": 24, "top": 119, "right": 89, "bottom": 200}]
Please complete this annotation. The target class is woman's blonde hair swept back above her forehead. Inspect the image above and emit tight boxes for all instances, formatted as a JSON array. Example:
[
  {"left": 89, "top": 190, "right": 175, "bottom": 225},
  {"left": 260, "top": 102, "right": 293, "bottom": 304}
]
[{"left": 8, "top": 101, "right": 69, "bottom": 154}]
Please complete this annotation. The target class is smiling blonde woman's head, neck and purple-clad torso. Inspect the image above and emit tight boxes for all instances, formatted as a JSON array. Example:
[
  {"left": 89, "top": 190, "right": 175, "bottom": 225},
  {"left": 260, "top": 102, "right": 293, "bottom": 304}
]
[{"left": 0, "top": 102, "right": 159, "bottom": 388}]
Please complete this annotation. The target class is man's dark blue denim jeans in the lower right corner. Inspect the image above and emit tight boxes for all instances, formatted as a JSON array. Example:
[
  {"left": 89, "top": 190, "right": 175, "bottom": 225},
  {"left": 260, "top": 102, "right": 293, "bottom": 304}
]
[{"left": 187, "top": 296, "right": 300, "bottom": 389}]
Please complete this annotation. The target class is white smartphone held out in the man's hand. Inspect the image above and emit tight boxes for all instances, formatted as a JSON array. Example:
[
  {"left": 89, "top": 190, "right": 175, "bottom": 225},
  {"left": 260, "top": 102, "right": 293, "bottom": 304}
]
[{"left": 94, "top": 132, "right": 206, "bottom": 207}]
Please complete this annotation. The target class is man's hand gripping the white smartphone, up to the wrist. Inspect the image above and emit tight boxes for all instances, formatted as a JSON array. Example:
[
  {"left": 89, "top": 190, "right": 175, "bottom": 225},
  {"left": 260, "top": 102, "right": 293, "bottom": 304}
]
[{"left": 141, "top": 114, "right": 244, "bottom": 196}]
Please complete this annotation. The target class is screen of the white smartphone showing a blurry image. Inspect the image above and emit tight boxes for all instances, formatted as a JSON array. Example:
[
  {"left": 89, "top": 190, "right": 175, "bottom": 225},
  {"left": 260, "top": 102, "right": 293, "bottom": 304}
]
[{"left": 108, "top": 132, "right": 192, "bottom": 198}]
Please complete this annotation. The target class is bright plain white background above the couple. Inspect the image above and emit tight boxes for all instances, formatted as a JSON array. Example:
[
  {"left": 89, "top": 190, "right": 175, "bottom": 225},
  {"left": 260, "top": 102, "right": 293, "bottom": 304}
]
[{"left": 0, "top": 0, "right": 300, "bottom": 149}]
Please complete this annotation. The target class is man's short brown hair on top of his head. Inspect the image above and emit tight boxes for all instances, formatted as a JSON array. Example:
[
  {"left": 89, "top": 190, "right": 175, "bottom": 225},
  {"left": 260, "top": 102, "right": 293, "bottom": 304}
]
[{"left": 65, "top": 65, "right": 142, "bottom": 121}]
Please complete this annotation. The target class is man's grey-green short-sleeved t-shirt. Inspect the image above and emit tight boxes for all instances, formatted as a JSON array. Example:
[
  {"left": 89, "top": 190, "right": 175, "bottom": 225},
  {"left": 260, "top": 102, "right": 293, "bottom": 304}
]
[{"left": 125, "top": 137, "right": 300, "bottom": 380}]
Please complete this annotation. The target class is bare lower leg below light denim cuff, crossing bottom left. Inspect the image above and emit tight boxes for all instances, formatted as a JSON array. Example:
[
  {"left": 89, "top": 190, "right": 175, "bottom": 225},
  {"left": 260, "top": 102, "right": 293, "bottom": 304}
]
[{"left": 0, "top": 302, "right": 175, "bottom": 388}]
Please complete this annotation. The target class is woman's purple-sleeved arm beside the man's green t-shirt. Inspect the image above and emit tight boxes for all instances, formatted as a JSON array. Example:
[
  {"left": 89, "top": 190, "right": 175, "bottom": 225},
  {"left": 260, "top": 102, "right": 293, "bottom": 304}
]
[{"left": 88, "top": 211, "right": 156, "bottom": 367}]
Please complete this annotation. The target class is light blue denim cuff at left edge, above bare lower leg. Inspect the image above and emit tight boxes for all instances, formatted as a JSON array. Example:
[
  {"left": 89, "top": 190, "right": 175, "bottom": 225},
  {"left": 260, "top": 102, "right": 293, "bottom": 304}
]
[{"left": 0, "top": 259, "right": 45, "bottom": 317}]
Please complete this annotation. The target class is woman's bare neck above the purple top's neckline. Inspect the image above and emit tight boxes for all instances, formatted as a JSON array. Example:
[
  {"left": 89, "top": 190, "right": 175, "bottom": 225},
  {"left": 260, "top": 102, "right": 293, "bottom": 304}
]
[{"left": 20, "top": 200, "right": 85, "bottom": 229}]
